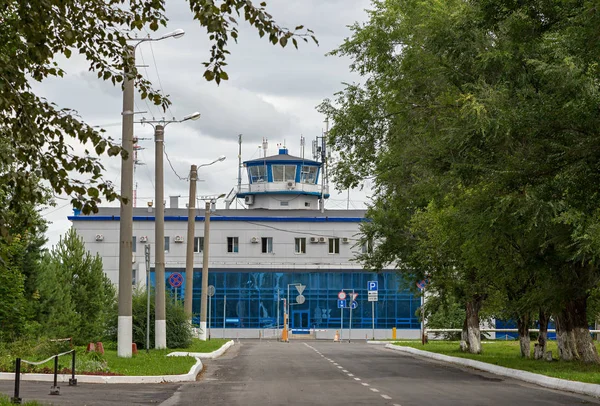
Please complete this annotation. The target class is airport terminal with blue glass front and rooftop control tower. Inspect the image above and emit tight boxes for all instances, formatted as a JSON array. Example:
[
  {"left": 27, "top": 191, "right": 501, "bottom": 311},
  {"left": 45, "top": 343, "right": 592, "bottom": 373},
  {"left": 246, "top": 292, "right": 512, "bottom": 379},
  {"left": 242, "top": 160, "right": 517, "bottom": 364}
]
[{"left": 69, "top": 148, "right": 421, "bottom": 339}]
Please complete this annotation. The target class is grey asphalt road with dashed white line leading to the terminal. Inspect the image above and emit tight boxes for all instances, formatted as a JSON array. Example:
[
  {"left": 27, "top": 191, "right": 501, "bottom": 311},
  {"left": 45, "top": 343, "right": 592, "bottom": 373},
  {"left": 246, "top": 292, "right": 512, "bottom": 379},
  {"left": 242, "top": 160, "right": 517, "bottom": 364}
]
[{"left": 0, "top": 340, "right": 600, "bottom": 406}]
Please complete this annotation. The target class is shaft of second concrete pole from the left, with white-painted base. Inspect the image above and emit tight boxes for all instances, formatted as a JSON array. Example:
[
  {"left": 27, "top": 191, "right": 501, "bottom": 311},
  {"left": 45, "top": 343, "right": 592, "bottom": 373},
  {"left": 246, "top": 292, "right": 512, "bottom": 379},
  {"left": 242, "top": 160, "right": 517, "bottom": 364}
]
[{"left": 154, "top": 125, "right": 167, "bottom": 349}]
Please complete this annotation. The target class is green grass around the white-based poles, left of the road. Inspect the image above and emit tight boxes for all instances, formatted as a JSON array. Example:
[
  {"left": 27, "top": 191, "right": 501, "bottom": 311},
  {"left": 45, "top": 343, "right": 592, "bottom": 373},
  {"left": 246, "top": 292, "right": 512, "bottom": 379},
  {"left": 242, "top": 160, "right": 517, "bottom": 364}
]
[{"left": 104, "top": 338, "right": 228, "bottom": 376}]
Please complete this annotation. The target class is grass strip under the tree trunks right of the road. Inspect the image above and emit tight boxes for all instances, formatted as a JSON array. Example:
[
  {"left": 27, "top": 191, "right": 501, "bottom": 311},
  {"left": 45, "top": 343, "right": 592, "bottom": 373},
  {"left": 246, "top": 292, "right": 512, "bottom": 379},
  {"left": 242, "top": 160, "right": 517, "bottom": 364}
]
[{"left": 395, "top": 341, "right": 600, "bottom": 384}]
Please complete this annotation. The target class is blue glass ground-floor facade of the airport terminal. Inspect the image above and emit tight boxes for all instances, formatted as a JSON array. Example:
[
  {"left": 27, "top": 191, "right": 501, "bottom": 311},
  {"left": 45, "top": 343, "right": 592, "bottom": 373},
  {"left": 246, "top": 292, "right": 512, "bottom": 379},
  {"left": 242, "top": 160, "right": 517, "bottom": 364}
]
[{"left": 150, "top": 269, "right": 421, "bottom": 329}]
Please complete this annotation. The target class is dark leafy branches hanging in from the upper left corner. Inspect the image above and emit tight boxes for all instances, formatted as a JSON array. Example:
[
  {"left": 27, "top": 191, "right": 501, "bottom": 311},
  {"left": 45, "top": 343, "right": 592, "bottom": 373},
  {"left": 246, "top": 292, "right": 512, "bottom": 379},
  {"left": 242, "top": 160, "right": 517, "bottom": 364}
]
[{"left": 0, "top": 0, "right": 316, "bottom": 236}]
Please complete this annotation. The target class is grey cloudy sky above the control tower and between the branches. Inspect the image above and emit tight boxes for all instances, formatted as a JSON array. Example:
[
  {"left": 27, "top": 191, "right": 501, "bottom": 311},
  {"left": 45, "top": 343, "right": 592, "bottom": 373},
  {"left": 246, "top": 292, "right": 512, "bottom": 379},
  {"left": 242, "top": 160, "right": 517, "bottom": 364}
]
[{"left": 34, "top": 0, "right": 370, "bottom": 245}]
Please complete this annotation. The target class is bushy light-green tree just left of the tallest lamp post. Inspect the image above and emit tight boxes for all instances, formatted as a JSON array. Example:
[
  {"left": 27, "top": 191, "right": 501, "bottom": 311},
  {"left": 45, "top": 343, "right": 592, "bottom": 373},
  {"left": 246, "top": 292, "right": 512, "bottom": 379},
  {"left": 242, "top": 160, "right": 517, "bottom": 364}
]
[{"left": 39, "top": 229, "right": 115, "bottom": 344}]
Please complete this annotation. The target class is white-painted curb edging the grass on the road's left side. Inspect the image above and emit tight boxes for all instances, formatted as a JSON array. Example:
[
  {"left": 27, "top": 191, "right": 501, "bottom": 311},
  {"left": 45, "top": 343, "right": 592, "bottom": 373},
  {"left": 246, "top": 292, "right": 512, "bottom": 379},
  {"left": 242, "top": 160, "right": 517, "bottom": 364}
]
[{"left": 0, "top": 340, "right": 234, "bottom": 383}]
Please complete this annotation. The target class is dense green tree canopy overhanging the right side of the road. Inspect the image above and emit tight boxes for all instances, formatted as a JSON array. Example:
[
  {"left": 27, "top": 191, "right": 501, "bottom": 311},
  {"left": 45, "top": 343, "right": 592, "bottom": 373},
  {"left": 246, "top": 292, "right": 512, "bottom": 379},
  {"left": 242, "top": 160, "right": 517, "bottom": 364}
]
[{"left": 320, "top": 0, "right": 600, "bottom": 362}]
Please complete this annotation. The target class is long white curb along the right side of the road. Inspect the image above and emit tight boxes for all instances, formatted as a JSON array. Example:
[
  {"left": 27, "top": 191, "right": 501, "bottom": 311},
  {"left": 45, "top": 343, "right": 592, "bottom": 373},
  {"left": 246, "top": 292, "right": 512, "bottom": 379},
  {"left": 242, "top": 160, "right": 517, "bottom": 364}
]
[{"left": 385, "top": 344, "right": 600, "bottom": 398}]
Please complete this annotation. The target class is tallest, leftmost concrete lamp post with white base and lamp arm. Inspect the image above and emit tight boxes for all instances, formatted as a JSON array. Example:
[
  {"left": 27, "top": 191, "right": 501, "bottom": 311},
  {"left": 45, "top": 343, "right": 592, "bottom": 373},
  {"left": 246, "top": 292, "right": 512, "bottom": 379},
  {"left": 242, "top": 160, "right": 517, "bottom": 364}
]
[{"left": 117, "top": 29, "right": 185, "bottom": 358}]
